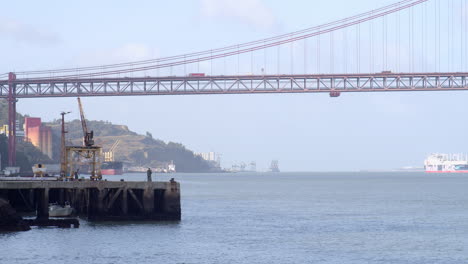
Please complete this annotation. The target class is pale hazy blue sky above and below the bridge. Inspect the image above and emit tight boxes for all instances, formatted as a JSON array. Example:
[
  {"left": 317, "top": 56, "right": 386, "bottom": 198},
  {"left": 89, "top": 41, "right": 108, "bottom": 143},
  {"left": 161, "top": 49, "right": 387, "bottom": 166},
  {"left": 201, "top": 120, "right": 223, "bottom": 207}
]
[{"left": 0, "top": 0, "right": 468, "bottom": 171}]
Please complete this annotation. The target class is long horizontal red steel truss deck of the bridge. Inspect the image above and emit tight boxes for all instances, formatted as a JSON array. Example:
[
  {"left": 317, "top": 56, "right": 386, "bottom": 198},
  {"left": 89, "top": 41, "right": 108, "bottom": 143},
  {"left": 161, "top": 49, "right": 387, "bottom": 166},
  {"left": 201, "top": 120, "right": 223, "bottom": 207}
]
[{"left": 0, "top": 73, "right": 468, "bottom": 98}]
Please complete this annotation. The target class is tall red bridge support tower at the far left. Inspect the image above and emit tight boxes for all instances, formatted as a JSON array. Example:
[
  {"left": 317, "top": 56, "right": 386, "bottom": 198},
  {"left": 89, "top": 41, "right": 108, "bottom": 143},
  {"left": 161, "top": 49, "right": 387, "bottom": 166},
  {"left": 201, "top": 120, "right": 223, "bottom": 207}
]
[{"left": 7, "top": 72, "right": 16, "bottom": 166}]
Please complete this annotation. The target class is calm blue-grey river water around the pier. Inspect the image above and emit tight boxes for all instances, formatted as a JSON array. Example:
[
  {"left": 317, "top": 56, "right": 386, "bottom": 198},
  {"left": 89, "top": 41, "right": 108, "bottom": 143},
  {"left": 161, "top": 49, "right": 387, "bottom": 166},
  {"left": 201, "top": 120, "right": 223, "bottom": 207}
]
[{"left": 0, "top": 172, "right": 468, "bottom": 264}]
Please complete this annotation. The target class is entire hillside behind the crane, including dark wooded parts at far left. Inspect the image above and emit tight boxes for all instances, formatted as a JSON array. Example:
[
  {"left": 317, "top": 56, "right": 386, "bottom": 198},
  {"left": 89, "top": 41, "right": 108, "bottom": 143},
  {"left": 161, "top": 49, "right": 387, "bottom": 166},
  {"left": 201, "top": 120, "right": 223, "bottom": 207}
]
[{"left": 0, "top": 100, "right": 213, "bottom": 172}]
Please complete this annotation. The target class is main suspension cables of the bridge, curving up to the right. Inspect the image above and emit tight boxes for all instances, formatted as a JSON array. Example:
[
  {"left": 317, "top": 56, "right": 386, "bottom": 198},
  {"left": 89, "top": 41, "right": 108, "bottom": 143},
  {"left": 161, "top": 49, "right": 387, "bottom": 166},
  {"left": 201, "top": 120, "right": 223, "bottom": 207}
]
[{"left": 6, "top": 0, "right": 428, "bottom": 79}]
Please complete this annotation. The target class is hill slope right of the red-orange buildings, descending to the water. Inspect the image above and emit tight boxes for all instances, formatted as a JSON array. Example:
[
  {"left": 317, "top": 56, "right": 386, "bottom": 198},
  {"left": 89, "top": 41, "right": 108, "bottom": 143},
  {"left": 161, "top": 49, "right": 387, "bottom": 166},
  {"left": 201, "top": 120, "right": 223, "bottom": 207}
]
[{"left": 47, "top": 120, "right": 212, "bottom": 172}]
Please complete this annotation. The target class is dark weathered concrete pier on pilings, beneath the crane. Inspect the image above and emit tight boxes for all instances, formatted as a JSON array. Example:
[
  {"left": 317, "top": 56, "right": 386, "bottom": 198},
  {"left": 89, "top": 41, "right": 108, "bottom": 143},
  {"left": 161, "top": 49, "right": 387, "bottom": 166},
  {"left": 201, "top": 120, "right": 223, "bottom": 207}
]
[{"left": 0, "top": 181, "right": 181, "bottom": 221}]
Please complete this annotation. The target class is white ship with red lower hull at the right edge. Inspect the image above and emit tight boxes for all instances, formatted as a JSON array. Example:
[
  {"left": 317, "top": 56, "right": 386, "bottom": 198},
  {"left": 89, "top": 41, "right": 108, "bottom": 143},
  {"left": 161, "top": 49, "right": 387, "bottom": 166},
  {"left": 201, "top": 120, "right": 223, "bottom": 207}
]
[{"left": 424, "top": 154, "right": 468, "bottom": 173}]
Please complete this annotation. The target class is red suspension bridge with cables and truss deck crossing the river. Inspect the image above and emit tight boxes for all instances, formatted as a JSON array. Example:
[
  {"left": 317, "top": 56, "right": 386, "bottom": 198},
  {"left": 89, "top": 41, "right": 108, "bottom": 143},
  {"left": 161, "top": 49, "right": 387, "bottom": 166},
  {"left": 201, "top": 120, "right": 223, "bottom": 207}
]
[{"left": 0, "top": 0, "right": 468, "bottom": 165}]
